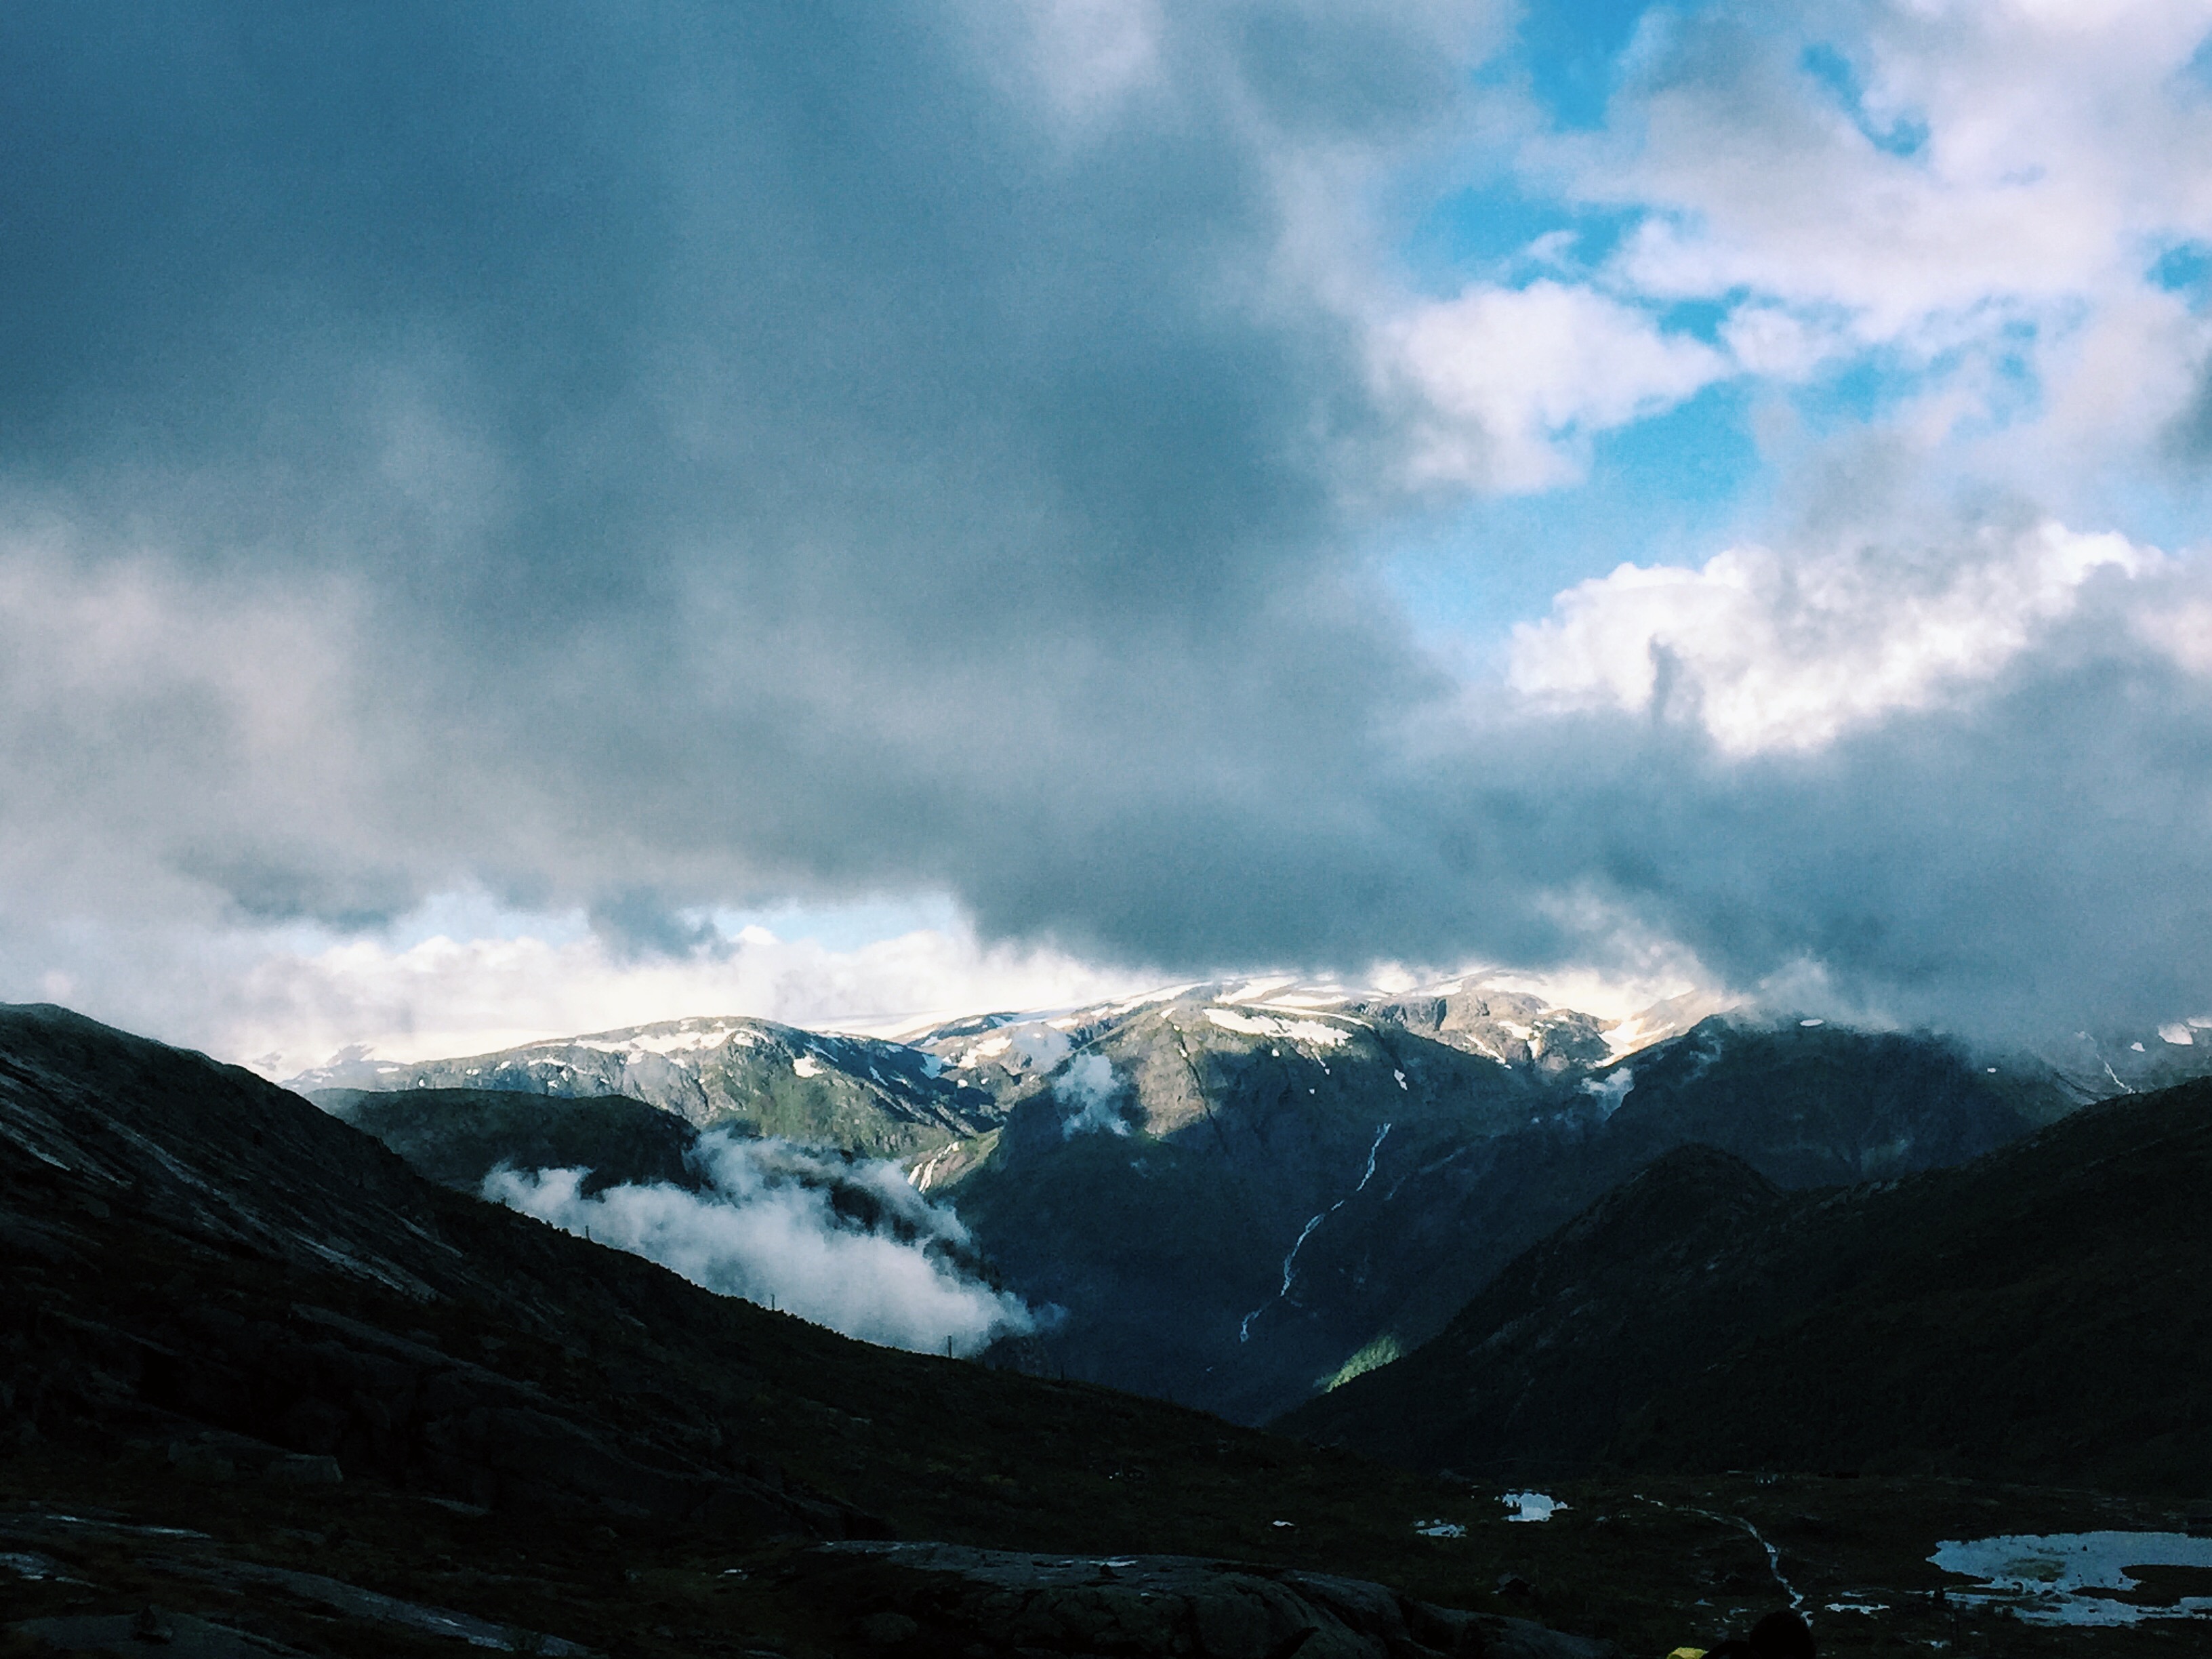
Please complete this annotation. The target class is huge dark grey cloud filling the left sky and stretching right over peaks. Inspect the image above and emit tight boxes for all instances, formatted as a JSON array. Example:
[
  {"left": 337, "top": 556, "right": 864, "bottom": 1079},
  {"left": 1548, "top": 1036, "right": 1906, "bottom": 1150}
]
[{"left": 0, "top": 2, "right": 2212, "bottom": 1040}]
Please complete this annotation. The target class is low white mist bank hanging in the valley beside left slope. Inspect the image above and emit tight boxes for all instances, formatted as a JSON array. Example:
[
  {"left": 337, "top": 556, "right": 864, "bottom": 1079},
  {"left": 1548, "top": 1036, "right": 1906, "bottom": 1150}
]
[{"left": 485, "top": 1132, "right": 1038, "bottom": 1354}]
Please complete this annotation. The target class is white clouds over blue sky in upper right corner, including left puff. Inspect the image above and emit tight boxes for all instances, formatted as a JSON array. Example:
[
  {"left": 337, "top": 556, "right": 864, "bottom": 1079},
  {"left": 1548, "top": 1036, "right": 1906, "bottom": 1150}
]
[{"left": 1367, "top": 0, "right": 2212, "bottom": 520}]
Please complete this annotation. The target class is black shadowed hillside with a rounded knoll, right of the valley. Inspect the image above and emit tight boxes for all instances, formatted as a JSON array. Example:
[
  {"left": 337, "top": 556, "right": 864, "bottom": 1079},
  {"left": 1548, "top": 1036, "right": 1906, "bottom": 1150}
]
[{"left": 1283, "top": 1084, "right": 2212, "bottom": 1491}]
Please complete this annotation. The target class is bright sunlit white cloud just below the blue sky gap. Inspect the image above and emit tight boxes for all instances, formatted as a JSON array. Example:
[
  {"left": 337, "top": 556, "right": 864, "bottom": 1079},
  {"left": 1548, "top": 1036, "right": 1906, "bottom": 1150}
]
[{"left": 1511, "top": 522, "right": 2163, "bottom": 754}]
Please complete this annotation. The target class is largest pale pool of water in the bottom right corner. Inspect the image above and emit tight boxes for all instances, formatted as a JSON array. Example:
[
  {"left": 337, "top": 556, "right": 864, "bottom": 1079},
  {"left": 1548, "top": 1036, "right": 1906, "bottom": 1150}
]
[{"left": 1929, "top": 1533, "right": 2212, "bottom": 1626}]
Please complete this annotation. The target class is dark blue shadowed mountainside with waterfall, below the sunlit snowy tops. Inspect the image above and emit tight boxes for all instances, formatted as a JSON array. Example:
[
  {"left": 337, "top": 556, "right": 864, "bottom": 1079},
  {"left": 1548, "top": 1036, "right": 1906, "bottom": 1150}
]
[{"left": 1097, "top": 1017, "right": 2044, "bottom": 1418}]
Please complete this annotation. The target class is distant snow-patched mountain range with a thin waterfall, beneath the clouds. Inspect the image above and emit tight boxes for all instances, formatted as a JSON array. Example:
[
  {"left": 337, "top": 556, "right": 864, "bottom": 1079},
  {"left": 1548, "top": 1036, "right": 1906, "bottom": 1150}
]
[{"left": 272, "top": 980, "right": 2212, "bottom": 1422}]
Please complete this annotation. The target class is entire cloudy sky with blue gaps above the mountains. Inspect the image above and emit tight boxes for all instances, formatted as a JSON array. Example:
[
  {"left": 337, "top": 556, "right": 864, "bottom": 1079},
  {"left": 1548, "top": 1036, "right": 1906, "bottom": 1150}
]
[{"left": 0, "top": 0, "right": 2212, "bottom": 1075}]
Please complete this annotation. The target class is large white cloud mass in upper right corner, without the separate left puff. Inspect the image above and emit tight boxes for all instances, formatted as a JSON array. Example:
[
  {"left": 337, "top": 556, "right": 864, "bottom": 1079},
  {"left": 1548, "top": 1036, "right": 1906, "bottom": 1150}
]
[{"left": 1522, "top": 0, "right": 2212, "bottom": 493}]
